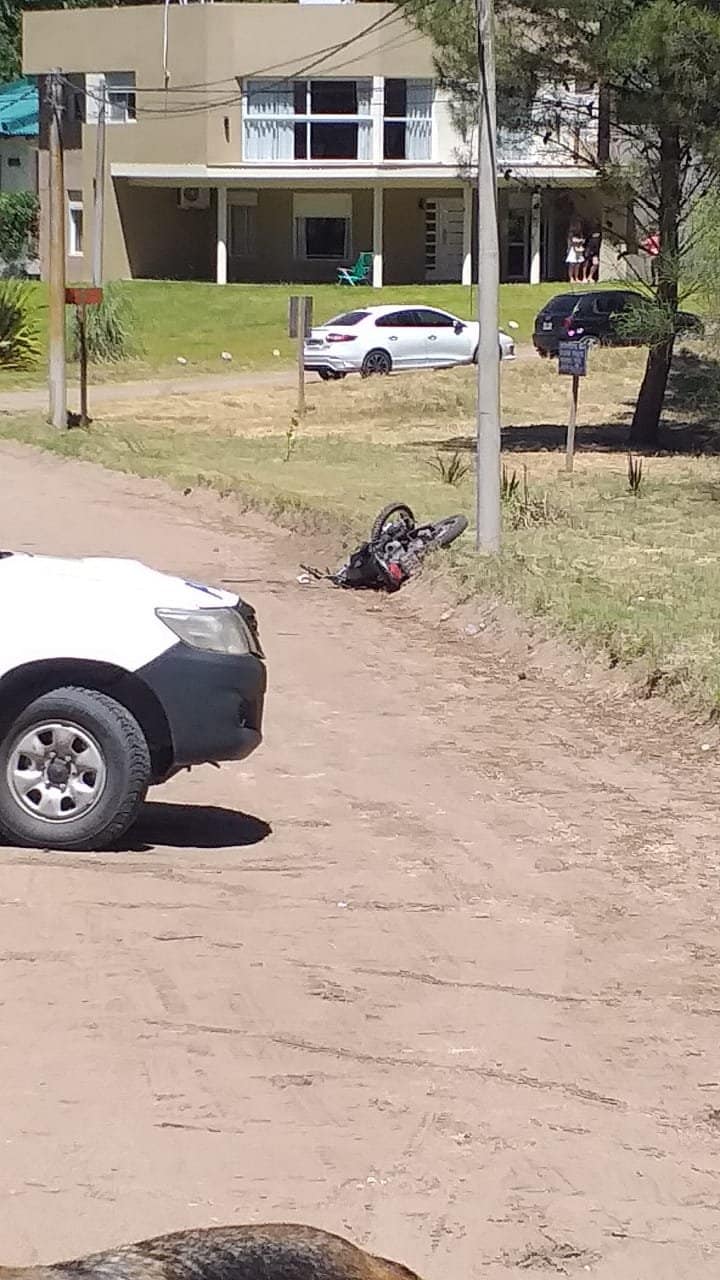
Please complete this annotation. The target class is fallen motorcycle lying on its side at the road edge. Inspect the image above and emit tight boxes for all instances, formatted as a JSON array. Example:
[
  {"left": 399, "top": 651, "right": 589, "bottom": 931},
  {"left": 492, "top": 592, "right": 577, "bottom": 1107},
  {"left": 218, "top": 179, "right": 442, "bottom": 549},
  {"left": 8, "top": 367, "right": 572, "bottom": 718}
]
[{"left": 302, "top": 502, "right": 468, "bottom": 591}]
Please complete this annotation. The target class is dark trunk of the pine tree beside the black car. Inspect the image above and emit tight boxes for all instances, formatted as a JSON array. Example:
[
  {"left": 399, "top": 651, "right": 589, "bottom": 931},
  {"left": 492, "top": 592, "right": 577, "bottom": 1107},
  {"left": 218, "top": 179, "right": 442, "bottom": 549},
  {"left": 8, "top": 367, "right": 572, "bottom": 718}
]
[{"left": 630, "top": 124, "right": 682, "bottom": 449}]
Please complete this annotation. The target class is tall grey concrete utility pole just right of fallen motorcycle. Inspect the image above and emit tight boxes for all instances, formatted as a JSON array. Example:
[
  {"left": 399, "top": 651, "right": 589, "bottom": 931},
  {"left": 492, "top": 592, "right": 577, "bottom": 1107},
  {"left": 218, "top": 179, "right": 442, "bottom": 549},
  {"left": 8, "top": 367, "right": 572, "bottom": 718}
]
[{"left": 475, "top": 0, "right": 501, "bottom": 554}]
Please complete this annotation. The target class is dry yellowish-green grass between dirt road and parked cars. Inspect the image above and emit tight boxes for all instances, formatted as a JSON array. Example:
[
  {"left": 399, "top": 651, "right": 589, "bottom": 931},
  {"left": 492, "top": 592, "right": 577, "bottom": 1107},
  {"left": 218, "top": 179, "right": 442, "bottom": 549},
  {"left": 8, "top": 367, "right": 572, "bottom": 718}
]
[{"left": 0, "top": 351, "right": 720, "bottom": 713}]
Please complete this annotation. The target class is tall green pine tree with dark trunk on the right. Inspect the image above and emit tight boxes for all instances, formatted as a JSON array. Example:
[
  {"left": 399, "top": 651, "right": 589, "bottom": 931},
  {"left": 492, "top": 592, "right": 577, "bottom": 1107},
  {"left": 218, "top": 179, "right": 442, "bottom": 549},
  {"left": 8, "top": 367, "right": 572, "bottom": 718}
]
[{"left": 405, "top": 0, "right": 720, "bottom": 448}]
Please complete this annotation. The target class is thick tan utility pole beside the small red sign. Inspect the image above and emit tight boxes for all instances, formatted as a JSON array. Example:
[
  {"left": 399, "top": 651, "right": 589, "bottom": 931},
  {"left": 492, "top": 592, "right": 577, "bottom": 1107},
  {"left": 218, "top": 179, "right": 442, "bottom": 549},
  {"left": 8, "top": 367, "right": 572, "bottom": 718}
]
[{"left": 47, "top": 70, "right": 68, "bottom": 431}]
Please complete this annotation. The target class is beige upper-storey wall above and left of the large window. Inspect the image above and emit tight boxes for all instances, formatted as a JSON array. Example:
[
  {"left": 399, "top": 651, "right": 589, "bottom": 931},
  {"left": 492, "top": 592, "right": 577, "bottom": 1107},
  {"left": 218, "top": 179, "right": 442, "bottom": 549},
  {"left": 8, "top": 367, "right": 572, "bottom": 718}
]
[{"left": 23, "top": 4, "right": 433, "bottom": 174}]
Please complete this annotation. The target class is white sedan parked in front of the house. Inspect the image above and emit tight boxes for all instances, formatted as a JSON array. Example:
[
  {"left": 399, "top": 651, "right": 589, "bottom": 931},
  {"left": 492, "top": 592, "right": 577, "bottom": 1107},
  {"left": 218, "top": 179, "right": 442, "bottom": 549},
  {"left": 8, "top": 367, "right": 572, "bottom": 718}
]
[{"left": 299, "top": 306, "right": 515, "bottom": 381}]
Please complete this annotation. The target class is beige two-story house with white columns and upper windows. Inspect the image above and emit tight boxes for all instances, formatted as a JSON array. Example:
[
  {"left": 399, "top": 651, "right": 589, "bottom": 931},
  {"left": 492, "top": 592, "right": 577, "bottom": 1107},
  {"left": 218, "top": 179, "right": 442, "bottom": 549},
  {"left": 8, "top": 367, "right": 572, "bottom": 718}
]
[{"left": 24, "top": 3, "right": 621, "bottom": 285}]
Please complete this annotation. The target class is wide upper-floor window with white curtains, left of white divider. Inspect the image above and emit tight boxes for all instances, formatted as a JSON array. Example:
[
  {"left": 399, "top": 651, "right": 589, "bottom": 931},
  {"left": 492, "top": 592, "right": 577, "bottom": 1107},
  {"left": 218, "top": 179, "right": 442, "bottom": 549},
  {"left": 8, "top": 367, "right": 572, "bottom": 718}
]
[{"left": 245, "top": 79, "right": 373, "bottom": 161}]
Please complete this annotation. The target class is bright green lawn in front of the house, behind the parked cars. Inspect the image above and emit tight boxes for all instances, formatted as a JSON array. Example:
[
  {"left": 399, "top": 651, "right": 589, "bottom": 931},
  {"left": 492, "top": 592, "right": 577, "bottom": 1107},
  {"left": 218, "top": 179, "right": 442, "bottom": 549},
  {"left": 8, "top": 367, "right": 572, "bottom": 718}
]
[{"left": 0, "top": 280, "right": 579, "bottom": 388}]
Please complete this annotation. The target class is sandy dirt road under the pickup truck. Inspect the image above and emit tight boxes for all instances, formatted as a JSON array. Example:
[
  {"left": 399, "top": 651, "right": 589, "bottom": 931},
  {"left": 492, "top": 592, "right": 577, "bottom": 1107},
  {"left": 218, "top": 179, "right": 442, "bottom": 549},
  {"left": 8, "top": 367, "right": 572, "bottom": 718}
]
[{"left": 0, "top": 445, "right": 720, "bottom": 1280}]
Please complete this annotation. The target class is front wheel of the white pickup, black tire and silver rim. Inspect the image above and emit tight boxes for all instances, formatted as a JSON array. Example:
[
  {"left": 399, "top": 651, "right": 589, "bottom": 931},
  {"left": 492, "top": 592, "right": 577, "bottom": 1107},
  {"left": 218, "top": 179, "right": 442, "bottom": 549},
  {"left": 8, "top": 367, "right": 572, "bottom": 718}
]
[{"left": 0, "top": 687, "right": 151, "bottom": 851}]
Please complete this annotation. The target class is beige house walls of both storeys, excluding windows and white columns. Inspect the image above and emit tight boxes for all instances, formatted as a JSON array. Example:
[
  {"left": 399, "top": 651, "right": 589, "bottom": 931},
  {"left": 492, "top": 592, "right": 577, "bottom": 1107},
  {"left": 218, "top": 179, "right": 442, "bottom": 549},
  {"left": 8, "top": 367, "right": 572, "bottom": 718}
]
[{"left": 23, "top": 4, "right": 433, "bottom": 280}]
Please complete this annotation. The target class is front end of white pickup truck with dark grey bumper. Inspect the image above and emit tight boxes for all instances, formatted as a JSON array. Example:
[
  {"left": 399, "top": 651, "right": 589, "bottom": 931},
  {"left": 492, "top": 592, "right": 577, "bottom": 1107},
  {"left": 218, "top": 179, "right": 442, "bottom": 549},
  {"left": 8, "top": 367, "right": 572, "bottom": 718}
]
[{"left": 0, "top": 552, "right": 265, "bottom": 850}]
